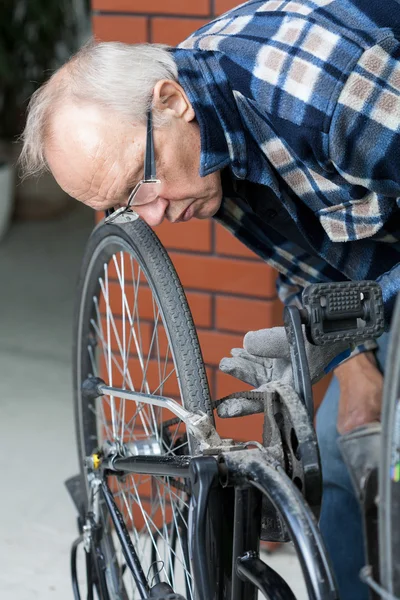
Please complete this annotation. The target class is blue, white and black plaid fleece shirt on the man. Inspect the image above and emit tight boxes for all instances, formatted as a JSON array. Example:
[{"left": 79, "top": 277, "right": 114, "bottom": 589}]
[{"left": 171, "top": 0, "right": 400, "bottom": 324}]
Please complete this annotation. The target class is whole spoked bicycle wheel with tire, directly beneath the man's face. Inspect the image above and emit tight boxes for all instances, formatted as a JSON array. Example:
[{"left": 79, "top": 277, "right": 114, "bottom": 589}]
[{"left": 74, "top": 219, "right": 212, "bottom": 600}]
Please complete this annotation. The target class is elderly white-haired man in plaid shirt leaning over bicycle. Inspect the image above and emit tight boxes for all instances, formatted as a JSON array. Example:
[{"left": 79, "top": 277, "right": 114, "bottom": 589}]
[{"left": 22, "top": 0, "right": 400, "bottom": 600}]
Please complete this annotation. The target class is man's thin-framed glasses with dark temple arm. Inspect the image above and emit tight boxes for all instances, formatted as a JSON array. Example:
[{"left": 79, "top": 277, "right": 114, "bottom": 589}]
[{"left": 105, "top": 110, "right": 161, "bottom": 223}]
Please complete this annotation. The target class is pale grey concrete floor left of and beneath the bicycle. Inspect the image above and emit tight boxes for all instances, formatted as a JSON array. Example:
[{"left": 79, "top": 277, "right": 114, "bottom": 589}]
[{"left": 0, "top": 204, "right": 307, "bottom": 600}]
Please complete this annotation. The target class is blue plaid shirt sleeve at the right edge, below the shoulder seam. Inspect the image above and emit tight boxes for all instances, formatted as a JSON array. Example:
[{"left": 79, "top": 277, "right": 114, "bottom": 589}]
[{"left": 329, "top": 33, "right": 400, "bottom": 327}]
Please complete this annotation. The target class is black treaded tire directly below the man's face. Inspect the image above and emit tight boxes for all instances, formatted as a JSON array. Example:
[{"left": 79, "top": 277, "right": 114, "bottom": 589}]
[{"left": 73, "top": 219, "right": 215, "bottom": 598}]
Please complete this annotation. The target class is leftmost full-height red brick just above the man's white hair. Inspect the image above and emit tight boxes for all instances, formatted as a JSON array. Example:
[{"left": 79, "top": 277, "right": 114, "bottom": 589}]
[{"left": 92, "top": 15, "right": 147, "bottom": 44}]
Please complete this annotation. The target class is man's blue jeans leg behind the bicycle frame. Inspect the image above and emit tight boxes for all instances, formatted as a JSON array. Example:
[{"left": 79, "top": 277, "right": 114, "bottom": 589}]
[{"left": 316, "top": 333, "right": 389, "bottom": 600}]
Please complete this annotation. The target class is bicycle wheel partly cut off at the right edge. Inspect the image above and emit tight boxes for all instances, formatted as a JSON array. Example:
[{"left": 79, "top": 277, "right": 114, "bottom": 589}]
[{"left": 379, "top": 295, "right": 400, "bottom": 597}]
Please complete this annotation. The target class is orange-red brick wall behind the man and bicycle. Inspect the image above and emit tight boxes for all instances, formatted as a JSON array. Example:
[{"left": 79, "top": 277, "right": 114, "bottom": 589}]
[{"left": 92, "top": 0, "right": 330, "bottom": 439}]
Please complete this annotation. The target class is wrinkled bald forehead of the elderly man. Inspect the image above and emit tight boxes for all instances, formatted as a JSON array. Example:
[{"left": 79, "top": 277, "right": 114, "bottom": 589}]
[{"left": 46, "top": 106, "right": 144, "bottom": 202}]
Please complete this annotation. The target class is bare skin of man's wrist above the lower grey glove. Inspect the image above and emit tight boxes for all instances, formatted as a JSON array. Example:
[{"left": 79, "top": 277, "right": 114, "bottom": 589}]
[{"left": 334, "top": 352, "right": 383, "bottom": 435}]
